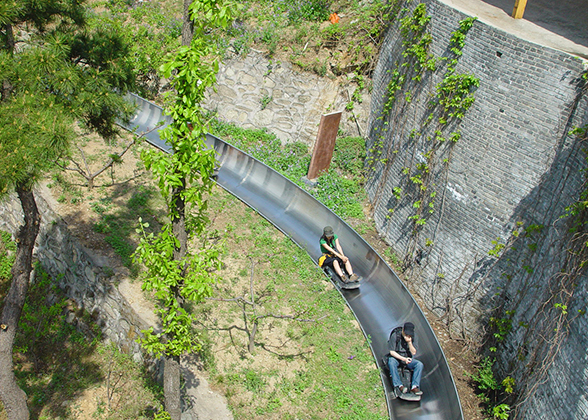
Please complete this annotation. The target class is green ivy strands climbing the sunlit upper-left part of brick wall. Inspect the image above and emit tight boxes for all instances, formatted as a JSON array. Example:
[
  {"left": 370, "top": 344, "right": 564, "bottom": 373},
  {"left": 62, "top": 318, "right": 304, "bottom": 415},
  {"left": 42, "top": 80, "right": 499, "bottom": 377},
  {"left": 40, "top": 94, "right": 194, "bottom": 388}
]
[{"left": 374, "top": 9, "right": 479, "bottom": 234}]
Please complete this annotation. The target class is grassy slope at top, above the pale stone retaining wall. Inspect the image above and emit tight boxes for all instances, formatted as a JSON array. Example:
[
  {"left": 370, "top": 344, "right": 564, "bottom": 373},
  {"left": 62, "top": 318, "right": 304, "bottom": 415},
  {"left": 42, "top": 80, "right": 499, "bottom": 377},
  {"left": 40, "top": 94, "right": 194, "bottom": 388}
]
[{"left": 214, "top": 0, "right": 398, "bottom": 77}]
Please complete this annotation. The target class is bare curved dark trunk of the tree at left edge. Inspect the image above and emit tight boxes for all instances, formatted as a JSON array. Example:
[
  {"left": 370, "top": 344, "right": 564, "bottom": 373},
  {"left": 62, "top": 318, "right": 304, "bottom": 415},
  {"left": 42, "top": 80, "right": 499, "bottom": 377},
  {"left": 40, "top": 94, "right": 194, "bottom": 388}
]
[{"left": 0, "top": 184, "right": 41, "bottom": 420}]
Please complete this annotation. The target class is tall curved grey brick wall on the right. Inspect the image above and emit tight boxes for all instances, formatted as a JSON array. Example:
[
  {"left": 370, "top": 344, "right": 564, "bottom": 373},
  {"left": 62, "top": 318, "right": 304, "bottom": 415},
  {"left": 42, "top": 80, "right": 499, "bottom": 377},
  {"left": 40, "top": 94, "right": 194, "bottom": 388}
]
[{"left": 366, "top": 0, "right": 588, "bottom": 419}]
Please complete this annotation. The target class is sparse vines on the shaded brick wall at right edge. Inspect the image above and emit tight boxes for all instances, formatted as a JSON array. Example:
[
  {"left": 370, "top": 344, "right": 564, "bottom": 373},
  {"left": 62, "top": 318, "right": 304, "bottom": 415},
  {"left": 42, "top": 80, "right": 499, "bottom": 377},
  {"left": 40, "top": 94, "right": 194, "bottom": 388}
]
[{"left": 487, "top": 72, "right": 588, "bottom": 418}]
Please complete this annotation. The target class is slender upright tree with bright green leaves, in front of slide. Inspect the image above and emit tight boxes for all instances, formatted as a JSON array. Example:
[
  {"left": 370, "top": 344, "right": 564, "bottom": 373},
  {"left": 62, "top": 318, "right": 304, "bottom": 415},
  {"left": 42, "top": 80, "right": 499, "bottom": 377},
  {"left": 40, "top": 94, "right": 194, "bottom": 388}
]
[{"left": 135, "top": 0, "right": 234, "bottom": 419}]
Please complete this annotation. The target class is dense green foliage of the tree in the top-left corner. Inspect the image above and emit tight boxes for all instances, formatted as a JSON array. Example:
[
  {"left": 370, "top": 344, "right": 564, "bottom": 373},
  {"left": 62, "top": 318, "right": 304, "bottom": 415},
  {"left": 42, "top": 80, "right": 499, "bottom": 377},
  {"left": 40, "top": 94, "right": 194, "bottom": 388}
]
[{"left": 0, "top": 0, "right": 133, "bottom": 194}]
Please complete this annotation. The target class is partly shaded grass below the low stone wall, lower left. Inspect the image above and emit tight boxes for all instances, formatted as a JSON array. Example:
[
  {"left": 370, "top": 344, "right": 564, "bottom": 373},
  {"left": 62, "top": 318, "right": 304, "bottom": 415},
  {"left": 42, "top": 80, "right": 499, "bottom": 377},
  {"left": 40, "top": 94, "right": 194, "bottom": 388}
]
[{"left": 0, "top": 256, "right": 162, "bottom": 420}]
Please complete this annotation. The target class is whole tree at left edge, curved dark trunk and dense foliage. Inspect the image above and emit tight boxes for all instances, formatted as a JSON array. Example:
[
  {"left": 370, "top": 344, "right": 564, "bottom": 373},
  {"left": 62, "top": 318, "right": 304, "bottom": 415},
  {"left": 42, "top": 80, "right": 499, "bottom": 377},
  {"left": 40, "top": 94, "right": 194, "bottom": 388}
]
[{"left": 0, "top": 0, "right": 133, "bottom": 419}]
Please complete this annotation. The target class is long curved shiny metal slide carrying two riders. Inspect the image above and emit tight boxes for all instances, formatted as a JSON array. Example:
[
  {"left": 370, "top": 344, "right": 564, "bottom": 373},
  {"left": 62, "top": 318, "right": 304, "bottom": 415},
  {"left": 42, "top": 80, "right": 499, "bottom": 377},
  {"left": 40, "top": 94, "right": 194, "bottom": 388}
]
[{"left": 125, "top": 95, "right": 463, "bottom": 420}]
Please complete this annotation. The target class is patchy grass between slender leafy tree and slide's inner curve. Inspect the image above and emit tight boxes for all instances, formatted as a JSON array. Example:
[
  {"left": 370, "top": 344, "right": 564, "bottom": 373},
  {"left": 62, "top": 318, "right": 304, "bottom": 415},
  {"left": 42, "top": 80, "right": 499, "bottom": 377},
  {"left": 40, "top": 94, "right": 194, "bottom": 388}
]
[{"left": 195, "top": 192, "right": 387, "bottom": 419}]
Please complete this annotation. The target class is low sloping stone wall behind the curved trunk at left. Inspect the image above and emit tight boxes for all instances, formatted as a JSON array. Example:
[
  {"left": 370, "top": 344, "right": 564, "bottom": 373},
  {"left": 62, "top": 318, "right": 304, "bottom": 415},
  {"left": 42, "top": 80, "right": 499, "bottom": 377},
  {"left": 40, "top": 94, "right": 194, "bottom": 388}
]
[{"left": 0, "top": 193, "right": 150, "bottom": 362}]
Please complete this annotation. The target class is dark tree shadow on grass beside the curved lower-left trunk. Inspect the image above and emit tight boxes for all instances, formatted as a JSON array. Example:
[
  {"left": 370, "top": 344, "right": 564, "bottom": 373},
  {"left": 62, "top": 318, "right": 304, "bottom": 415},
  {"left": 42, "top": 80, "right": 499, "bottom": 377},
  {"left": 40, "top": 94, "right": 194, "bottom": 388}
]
[{"left": 14, "top": 268, "right": 103, "bottom": 419}]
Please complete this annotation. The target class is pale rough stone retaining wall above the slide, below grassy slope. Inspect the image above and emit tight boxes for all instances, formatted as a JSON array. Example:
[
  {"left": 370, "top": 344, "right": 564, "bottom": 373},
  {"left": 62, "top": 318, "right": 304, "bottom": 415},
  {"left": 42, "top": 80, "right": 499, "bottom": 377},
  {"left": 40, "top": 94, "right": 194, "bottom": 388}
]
[{"left": 204, "top": 52, "right": 370, "bottom": 146}]
